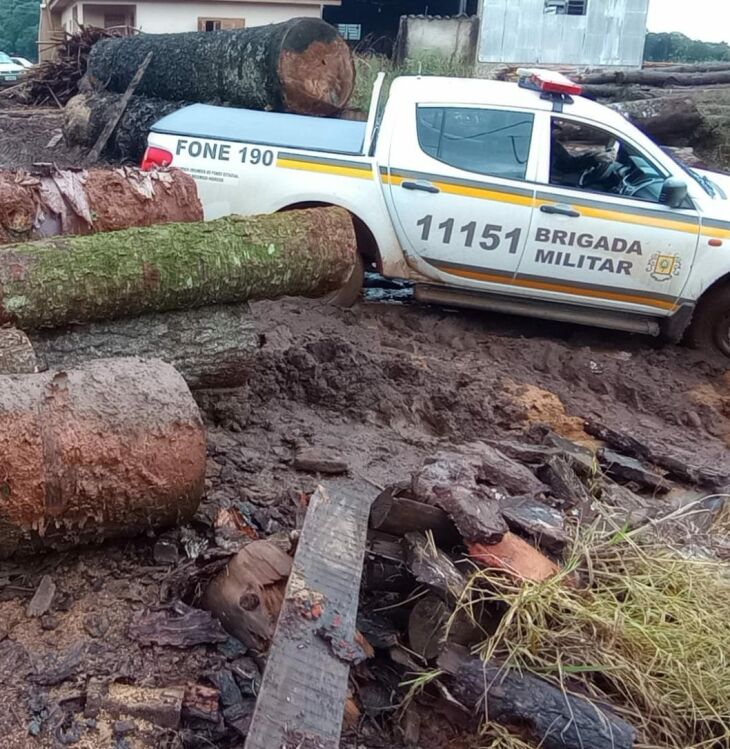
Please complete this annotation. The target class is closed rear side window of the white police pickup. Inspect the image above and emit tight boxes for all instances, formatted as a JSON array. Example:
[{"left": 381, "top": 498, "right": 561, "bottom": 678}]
[{"left": 416, "top": 107, "right": 534, "bottom": 179}]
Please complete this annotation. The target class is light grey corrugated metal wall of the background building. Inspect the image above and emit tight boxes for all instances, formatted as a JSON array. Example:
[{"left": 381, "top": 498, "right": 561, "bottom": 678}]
[{"left": 479, "top": 0, "right": 649, "bottom": 67}]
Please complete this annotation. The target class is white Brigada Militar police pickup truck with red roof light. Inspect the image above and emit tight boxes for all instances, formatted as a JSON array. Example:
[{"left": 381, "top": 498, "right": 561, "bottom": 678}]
[{"left": 143, "top": 70, "right": 730, "bottom": 356}]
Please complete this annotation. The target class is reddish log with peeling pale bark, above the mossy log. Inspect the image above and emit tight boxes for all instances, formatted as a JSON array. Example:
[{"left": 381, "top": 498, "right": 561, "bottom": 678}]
[{"left": 0, "top": 169, "right": 203, "bottom": 244}]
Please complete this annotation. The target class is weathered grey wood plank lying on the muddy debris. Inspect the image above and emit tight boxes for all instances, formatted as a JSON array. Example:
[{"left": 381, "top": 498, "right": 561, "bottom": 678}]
[{"left": 245, "top": 482, "right": 375, "bottom": 749}]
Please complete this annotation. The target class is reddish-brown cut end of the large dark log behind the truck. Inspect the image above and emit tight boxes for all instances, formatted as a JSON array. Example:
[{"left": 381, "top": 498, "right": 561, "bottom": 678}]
[{"left": 279, "top": 31, "right": 355, "bottom": 116}]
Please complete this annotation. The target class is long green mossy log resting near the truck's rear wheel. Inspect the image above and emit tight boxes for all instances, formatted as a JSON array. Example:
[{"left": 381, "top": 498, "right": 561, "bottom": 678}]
[{"left": 0, "top": 208, "right": 357, "bottom": 330}]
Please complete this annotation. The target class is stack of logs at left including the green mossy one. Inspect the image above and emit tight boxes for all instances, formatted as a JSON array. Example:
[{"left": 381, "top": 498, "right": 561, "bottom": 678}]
[{"left": 0, "top": 164, "right": 356, "bottom": 557}]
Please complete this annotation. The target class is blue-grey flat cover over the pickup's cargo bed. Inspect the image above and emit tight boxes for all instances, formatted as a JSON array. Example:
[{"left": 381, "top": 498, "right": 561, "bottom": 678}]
[{"left": 152, "top": 104, "right": 366, "bottom": 156}]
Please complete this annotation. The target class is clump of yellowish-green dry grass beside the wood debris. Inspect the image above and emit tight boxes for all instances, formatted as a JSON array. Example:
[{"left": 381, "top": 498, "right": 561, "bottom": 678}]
[{"left": 459, "top": 534, "right": 730, "bottom": 749}]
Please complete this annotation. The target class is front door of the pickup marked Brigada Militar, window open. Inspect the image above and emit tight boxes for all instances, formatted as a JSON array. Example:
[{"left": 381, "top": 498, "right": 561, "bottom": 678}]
[{"left": 515, "top": 113, "right": 699, "bottom": 316}]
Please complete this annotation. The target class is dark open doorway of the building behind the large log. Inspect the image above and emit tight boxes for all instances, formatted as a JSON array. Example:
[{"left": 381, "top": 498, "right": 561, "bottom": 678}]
[{"left": 324, "top": 0, "right": 479, "bottom": 55}]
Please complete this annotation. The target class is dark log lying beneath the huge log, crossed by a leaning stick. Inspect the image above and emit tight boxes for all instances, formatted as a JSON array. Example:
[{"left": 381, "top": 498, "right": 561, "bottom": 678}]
[{"left": 63, "top": 91, "right": 186, "bottom": 164}]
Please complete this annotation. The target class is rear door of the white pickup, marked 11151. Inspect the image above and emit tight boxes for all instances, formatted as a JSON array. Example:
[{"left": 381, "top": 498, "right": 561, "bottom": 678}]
[{"left": 382, "top": 105, "right": 535, "bottom": 291}]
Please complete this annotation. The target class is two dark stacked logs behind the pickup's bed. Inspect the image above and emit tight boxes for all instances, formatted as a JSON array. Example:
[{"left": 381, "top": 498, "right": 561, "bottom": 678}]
[{"left": 64, "top": 18, "right": 355, "bottom": 163}]
